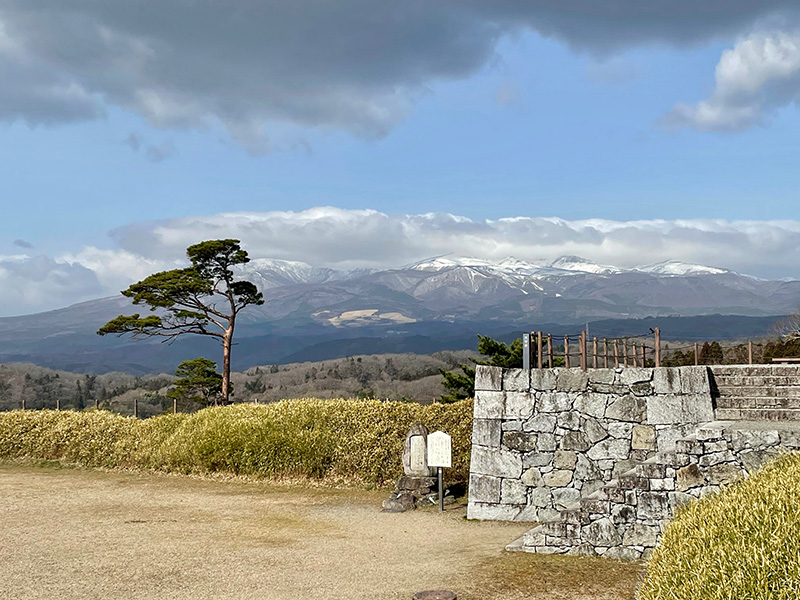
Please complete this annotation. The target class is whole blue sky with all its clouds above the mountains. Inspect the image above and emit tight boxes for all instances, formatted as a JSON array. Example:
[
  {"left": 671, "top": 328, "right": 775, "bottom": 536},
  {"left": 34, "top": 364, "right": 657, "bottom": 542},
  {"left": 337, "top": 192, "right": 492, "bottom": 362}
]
[{"left": 0, "top": 0, "right": 800, "bottom": 316}]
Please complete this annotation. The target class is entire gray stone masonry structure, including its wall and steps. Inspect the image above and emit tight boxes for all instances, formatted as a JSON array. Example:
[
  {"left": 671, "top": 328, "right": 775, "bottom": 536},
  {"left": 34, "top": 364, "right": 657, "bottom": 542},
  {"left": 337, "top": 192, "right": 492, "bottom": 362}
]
[{"left": 467, "top": 366, "right": 800, "bottom": 559}]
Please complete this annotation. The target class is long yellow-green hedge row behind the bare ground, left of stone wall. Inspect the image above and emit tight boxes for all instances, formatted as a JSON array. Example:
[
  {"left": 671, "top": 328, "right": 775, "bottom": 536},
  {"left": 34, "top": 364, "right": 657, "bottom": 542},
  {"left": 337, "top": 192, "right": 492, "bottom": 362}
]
[{"left": 0, "top": 399, "right": 472, "bottom": 484}]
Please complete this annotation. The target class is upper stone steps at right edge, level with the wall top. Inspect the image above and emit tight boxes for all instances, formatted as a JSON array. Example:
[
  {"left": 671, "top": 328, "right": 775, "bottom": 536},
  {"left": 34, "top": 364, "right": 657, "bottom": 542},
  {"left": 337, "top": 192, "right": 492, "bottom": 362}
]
[{"left": 710, "top": 365, "right": 800, "bottom": 421}]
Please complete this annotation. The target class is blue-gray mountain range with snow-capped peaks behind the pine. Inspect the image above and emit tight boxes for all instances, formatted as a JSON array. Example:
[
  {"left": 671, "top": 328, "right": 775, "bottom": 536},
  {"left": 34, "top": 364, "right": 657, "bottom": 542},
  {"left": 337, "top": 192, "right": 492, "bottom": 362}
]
[{"left": 0, "top": 256, "right": 800, "bottom": 373}]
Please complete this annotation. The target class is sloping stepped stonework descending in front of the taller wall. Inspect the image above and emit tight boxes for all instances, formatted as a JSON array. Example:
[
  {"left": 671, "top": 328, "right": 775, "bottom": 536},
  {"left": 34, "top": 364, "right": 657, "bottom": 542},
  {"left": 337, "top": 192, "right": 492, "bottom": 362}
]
[{"left": 507, "top": 420, "right": 800, "bottom": 560}]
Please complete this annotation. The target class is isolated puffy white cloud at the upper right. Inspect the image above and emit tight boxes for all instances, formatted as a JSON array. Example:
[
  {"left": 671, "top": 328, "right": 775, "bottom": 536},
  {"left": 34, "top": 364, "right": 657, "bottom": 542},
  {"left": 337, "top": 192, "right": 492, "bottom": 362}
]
[{"left": 663, "top": 30, "right": 800, "bottom": 131}]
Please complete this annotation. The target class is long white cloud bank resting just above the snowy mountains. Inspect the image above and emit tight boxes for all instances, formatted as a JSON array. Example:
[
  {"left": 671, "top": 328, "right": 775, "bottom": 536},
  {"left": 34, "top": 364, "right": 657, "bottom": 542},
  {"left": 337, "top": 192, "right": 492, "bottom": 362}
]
[{"left": 0, "top": 207, "right": 800, "bottom": 316}]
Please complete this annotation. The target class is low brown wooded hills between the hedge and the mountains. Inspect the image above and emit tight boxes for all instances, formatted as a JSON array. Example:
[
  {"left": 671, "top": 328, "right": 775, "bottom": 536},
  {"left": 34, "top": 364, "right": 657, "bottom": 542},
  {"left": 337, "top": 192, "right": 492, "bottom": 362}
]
[{"left": 0, "top": 351, "right": 475, "bottom": 417}]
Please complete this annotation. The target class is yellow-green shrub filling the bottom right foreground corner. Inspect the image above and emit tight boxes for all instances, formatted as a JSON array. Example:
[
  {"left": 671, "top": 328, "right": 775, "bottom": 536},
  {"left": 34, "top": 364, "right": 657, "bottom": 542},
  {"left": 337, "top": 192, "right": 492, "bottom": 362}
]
[{"left": 637, "top": 455, "right": 800, "bottom": 600}]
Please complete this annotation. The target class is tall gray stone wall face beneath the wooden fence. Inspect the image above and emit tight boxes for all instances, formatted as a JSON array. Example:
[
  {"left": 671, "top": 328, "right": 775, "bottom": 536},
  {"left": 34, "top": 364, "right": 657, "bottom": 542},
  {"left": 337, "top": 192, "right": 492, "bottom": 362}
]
[{"left": 467, "top": 366, "right": 714, "bottom": 521}]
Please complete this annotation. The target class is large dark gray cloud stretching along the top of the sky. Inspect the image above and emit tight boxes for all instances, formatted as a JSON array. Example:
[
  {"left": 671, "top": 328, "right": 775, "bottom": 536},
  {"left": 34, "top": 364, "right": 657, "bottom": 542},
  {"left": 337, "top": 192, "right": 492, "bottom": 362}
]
[{"left": 0, "top": 0, "right": 797, "bottom": 147}]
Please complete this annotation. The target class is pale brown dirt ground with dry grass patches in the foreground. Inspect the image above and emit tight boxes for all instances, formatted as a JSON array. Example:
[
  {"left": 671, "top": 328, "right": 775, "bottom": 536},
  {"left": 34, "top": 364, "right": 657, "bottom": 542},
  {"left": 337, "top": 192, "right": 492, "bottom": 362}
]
[{"left": 0, "top": 464, "right": 642, "bottom": 600}]
